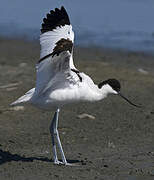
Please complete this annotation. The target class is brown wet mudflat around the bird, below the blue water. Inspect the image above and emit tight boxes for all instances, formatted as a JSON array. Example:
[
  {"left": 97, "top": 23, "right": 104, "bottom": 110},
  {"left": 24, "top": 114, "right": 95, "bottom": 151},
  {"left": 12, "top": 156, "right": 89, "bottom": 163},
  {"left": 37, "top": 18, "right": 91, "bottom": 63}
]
[{"left": 0, "top": 39, "right": 154, "bottom": 180}]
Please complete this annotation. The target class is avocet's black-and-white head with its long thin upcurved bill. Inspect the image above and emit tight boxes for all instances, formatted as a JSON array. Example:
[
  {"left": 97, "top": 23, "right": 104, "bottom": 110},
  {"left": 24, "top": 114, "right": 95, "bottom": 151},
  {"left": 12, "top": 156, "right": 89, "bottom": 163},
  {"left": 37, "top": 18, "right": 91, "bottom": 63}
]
[{"left": 98, "top": 79, "right": 140, "bottom": 107}]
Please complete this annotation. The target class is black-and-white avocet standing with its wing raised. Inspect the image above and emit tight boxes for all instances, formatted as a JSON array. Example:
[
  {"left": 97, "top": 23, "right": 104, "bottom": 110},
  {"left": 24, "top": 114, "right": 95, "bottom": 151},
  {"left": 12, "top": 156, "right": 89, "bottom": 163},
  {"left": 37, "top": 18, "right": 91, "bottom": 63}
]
[{"left": 11, "top": 6, "right": 139, "bottom": 165}]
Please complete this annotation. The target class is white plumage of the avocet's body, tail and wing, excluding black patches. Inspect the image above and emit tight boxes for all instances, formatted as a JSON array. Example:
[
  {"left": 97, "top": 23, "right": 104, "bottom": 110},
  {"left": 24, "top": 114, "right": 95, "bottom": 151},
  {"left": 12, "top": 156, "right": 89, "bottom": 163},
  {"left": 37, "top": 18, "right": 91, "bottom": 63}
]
[{"left": 12, "top": 8, "right": 103, "bottom": 110}]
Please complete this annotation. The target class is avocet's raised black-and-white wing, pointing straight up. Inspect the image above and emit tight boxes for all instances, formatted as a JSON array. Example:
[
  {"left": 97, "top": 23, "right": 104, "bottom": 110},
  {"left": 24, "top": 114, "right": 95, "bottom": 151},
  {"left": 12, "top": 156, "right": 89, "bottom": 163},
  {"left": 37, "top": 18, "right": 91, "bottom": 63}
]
[{"left": 36, "top": 7, "right": 76, "bottom": 92}]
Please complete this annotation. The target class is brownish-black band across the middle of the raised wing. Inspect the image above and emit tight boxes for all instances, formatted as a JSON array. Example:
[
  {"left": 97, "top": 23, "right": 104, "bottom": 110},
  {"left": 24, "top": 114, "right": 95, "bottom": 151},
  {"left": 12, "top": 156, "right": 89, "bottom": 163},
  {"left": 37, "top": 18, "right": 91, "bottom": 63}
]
[{"left": 38, "top": 38, "right": 73, "bottom": 63}]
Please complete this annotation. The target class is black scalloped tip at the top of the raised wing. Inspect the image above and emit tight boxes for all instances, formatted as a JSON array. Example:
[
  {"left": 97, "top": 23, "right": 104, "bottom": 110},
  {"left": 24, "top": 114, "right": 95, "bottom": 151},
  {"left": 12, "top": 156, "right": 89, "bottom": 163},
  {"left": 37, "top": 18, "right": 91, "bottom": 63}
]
[{"left": 41, "top": 6, "right": 70, "bottom": 33}]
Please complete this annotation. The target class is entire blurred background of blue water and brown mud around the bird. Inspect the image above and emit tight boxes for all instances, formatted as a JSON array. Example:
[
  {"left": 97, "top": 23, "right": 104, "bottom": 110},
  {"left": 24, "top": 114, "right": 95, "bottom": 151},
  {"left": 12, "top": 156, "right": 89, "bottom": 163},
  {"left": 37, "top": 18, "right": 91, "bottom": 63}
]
[{"left": 0, "top": 0, "right": 154, "bottom": 180}]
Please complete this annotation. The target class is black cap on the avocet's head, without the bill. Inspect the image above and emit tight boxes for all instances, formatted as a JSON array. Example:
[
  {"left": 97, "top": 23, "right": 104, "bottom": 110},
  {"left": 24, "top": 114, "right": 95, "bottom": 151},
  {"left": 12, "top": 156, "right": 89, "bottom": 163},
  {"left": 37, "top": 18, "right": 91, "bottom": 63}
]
[{"left": 98, "top": 79, "right": 121, "bottom": 92}]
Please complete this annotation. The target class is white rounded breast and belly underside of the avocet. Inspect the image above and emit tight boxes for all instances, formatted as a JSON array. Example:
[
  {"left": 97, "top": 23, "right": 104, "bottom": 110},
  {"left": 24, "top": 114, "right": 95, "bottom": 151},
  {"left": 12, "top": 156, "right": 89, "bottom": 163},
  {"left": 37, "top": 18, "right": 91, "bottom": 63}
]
[{"left": 33, "top": 84, "right": 102, "bottom": 109}]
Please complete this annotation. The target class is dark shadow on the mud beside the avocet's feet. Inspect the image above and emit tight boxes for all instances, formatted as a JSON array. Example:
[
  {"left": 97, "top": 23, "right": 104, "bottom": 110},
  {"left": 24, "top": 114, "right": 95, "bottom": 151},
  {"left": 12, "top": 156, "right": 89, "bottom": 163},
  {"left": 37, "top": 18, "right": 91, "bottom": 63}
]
[{"left": 0, "top": 149, "right": 80, "bottom": 165}]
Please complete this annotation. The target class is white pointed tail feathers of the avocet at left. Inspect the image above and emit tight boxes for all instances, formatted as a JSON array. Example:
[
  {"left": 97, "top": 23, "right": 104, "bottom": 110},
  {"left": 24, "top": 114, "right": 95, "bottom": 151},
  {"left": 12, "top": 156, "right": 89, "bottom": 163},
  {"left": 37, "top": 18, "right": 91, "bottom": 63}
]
[{"left": 10, "top": 88, "right": 35, "bottom": 106}]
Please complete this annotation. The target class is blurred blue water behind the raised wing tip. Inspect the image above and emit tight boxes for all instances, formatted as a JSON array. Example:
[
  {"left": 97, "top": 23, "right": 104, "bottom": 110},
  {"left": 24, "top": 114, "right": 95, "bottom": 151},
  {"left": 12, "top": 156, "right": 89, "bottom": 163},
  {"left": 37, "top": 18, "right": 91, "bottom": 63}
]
[{"left": 0, "top": 0, "right": 154, "bottom": 53}]
